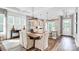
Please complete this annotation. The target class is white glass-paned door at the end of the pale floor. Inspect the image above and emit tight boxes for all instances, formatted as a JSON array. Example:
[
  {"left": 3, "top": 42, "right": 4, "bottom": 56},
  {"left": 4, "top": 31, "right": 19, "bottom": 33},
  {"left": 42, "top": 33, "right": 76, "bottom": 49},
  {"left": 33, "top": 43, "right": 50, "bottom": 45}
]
[{"left": 62, "top": 19, "right": 72, "bottom": 36}]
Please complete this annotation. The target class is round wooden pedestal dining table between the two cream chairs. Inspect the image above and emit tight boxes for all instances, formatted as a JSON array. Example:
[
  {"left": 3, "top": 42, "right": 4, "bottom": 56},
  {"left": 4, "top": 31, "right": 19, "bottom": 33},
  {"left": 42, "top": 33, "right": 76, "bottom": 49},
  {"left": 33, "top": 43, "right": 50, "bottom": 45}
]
[{"left": 27, "top": 32, "right": 43, "bottom": 50}]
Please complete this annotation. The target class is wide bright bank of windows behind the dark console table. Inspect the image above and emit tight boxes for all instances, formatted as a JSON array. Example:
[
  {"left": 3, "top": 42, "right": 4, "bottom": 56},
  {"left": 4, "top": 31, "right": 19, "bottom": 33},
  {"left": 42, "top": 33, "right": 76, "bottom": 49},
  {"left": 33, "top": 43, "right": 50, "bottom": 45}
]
[{"left": 7, "top": 14, "right": 26, "bottom": 38}]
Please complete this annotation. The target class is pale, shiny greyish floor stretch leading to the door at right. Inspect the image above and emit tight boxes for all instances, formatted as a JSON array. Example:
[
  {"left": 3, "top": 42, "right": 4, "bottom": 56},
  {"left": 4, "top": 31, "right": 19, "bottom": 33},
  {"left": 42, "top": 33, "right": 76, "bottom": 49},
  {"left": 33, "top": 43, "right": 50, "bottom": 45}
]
[{"left": 56, "top": 36, "right": 79, "bottom": 51}]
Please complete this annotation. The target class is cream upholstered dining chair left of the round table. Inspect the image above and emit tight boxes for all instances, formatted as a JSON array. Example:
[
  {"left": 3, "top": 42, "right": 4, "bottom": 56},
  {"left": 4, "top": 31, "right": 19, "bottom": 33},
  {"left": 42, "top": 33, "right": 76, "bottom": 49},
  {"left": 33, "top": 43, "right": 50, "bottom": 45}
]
[{"left": 20, "top": 30, "right": 33, "bottom": 49}]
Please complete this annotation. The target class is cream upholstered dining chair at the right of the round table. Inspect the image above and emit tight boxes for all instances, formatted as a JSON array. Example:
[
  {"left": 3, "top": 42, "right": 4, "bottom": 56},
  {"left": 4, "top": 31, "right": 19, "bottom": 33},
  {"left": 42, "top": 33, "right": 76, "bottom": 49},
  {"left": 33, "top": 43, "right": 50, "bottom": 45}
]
[{"left": 35, "top": 32, "right": 49, "bottom": 51}]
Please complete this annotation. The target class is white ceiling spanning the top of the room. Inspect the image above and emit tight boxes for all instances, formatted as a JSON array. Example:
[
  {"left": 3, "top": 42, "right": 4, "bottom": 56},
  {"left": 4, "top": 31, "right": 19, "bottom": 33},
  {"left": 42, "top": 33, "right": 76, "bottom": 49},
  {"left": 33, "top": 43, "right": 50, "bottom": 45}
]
[{"left": 4, "top": 7, "right": 75, "bottom": 19}]
